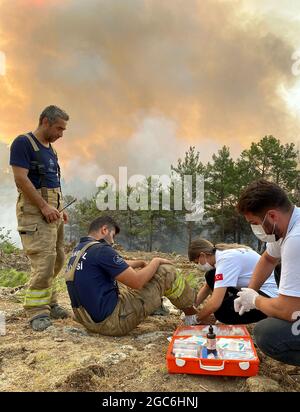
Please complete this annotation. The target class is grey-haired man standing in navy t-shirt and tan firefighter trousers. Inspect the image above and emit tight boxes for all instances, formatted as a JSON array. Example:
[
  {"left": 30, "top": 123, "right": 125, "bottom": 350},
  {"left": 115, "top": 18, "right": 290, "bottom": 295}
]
[{"left": 10, "top": 106, "right": 69, "bottom": 331}]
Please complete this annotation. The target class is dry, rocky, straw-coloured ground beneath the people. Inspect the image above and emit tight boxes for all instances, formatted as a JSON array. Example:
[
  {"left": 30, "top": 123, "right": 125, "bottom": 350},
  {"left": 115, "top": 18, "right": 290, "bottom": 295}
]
[{"left": 0, "top": 246, "right": 300, "bottom": 392}]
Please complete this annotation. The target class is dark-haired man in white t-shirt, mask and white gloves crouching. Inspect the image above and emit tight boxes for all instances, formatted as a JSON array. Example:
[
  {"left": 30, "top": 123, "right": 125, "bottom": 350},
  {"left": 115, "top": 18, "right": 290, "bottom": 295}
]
[{"left": 235, "top": 179, "right": 300, "bottom": 366}]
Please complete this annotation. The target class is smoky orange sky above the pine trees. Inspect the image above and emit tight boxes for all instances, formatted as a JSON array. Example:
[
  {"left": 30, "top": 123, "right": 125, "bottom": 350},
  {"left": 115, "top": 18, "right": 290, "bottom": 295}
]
[{"left": 0, "top": 0, "right": 300, "bottom": 181}]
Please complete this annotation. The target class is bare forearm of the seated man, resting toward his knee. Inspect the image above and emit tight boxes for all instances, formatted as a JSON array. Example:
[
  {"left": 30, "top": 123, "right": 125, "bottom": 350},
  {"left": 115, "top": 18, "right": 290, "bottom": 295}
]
[{"left": 116, "top": 258, "right": 171, "bottom": 289}]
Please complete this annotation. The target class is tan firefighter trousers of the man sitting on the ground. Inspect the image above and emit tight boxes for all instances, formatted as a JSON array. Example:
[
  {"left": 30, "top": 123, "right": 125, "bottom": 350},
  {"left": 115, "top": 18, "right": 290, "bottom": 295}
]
[{"left": 73, "top": 265, "right": 196, "bottom": 336}]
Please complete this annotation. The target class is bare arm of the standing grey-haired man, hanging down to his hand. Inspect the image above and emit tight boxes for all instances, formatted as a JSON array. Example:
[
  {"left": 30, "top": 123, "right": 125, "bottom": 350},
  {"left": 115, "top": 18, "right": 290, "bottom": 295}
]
[{"left": 12, "top": 166, "right": 60, "bottom": 223}]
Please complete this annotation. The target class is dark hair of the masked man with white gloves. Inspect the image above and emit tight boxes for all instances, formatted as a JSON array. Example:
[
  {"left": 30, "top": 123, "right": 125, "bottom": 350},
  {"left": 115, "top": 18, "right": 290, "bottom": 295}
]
[{"left": 236, "top": 179, "right": 292, "bottom": 216}]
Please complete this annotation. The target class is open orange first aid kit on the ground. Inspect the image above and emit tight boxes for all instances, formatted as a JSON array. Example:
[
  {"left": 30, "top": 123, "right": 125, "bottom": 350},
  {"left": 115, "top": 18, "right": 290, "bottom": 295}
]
[{"left": 166, "top": 325, "right": 259, "bottom": 376}]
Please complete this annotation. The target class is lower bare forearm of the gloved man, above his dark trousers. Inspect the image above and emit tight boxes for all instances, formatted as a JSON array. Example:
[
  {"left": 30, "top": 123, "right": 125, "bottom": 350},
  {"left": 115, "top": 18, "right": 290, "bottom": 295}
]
[{"left": 255, "top": 295, "right": 300, "bottom": 322}]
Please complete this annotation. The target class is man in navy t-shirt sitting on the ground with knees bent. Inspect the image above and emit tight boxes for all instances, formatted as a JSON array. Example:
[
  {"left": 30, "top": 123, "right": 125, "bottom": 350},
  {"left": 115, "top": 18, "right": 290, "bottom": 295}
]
[{"left": 65, "top": 216, "right": 195, "bottom": 336}]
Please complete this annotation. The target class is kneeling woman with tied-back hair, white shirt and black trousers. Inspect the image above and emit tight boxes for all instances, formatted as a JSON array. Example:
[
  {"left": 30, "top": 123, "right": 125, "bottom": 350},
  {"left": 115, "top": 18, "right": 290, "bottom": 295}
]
[{"left": 185, "top": 238, "right": 278, "bottom": 325}]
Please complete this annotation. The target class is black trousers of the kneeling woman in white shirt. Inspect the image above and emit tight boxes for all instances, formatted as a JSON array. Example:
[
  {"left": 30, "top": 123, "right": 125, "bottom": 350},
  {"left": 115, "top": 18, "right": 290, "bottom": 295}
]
[{"left": 205, "top": 269, "right": 269, "bottom": 325}]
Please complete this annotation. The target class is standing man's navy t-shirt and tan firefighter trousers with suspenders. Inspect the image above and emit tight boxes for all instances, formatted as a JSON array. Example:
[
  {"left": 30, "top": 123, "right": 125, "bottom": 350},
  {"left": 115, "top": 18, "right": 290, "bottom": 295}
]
[{"left": 10, "top": 133, "right": 65, "bottom": 319}]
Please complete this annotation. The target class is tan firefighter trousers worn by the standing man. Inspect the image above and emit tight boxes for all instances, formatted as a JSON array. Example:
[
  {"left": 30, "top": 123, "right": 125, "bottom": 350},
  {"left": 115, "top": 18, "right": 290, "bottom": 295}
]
[{"left": 17, "top": 188, "right": 65, "bottom": 318}]
